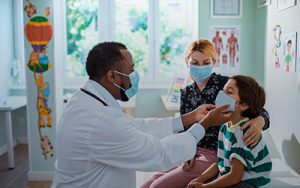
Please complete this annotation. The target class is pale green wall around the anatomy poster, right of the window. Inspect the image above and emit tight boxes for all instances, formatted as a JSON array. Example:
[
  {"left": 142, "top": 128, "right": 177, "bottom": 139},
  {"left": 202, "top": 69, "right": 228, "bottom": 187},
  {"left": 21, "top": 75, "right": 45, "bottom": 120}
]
[{"left": 199, "top": 0, "right": 265, "bottom": 83}]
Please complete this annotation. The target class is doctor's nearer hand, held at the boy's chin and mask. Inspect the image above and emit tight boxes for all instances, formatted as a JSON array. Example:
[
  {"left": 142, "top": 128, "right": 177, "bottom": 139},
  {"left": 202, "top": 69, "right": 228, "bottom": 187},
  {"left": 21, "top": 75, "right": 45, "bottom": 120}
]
[{"left": 200, "top": 105, "right": 232, "bottom": 129}]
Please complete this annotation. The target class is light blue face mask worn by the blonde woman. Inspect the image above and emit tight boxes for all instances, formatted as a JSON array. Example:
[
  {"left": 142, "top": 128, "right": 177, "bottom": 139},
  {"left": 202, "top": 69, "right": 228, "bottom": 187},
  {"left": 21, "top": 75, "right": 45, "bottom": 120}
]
[{"left": 190, "top": 64, "right": 212, "bottom": 83}]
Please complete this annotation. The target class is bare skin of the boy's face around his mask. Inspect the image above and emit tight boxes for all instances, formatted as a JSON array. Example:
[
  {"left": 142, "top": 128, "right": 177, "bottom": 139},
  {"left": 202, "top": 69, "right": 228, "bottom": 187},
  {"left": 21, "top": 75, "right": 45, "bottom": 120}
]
[{"left": 223, "top": 79, "right": 248, "bottom": 111}]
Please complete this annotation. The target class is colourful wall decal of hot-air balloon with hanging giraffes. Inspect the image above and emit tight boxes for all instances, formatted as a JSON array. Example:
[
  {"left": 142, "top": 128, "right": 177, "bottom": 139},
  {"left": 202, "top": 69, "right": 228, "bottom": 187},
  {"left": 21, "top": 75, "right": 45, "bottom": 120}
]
[{"left": 24, "top": 0, "right": 53, "bottom": 159}]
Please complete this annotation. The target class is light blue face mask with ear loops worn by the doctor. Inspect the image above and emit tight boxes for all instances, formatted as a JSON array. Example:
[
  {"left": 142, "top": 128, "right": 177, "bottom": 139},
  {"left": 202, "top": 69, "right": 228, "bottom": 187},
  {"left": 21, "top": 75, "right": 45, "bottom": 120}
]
[{"left": 114, "top": 71, "right": 140, "bottom": 101}]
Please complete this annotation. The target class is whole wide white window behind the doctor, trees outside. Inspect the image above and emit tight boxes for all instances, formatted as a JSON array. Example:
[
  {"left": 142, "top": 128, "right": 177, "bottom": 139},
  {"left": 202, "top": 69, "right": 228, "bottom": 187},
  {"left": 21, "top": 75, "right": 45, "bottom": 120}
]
[{"left": 65, "top": 0, "right": 198, "bottom": 85}]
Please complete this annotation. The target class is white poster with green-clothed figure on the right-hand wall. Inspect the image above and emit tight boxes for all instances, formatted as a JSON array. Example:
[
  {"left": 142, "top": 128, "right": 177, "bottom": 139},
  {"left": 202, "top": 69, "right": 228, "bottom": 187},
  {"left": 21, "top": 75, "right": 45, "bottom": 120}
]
[{"left": 281, "top": 32, "right": 297, "bottom": 72}]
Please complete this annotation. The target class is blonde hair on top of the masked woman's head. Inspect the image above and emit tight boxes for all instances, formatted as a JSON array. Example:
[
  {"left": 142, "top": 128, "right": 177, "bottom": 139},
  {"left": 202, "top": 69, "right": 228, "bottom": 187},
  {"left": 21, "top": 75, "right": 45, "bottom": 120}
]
[{"left": 185, "top": 39, "right": 216, "bottom": 62}]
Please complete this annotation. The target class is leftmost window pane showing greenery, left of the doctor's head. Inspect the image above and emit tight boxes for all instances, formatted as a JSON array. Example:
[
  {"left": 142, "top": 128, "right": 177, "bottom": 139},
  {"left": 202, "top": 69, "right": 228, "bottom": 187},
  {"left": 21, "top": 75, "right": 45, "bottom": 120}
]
[{"left": 65, "top": 0, "right": 99, "bottom": 78}]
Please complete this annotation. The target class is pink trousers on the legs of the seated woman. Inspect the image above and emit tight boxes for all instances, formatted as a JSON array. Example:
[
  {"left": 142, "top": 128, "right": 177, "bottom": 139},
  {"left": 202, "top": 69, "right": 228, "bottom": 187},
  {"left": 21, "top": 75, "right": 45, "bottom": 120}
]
[{"left": 142, "top": 148, "right": 217, "bottom": 188}]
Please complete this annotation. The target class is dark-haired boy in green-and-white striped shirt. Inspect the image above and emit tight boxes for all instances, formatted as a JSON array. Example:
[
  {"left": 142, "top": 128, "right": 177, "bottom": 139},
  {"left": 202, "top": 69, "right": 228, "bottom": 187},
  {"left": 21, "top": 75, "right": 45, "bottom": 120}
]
[{"left": 188, "top": 75, "right": 272, "bottom": 188}]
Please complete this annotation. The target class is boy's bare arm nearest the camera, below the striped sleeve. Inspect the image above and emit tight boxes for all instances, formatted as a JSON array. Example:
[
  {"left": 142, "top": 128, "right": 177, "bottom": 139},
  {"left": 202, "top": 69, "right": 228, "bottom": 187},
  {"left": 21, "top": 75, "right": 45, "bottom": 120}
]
[{"left": 203, "top": 158, "right": 245, "bottom": 188}]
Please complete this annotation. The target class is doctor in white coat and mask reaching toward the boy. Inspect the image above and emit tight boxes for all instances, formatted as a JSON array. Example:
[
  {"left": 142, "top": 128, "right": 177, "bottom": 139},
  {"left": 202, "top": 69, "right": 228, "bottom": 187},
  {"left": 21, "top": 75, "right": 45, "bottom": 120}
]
[{"left": 52, "top": 42, "right": 231, "bottom": 188}]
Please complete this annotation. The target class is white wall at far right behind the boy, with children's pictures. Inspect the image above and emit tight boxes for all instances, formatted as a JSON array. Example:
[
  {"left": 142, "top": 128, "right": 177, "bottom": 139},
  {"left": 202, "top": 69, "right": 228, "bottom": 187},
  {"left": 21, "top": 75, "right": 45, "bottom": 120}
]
[{"left": 265, "top": 0, "right": 300, "bottom": 173}]
